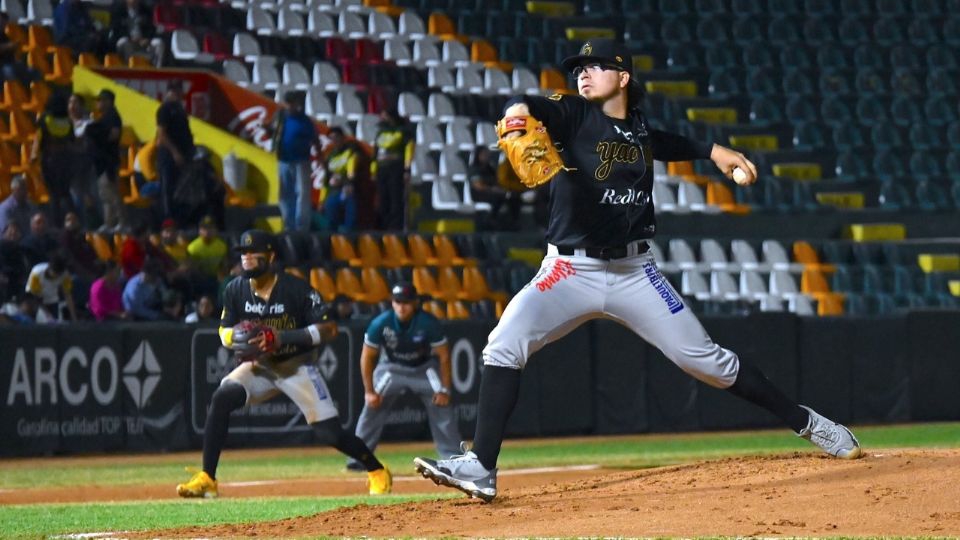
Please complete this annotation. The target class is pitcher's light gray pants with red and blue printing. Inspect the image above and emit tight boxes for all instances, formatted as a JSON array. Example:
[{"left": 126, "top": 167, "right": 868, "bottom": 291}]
[{"left": 483, "top": 246, "right": 740, "bottom": 388}]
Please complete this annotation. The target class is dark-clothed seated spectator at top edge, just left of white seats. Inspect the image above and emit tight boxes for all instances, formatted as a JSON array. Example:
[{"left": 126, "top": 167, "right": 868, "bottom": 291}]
[{"left": 108, "top": 0, "right": 165, "bottom": 67}]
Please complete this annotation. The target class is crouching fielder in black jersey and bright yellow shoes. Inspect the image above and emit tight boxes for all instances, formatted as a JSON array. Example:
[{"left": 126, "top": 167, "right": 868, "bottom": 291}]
[{"left": 177, "top": 231, "right": 392, "bottom": 497}]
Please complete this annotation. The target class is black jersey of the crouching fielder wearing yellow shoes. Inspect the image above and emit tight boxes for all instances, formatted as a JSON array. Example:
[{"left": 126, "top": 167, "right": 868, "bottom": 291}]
[{"left": 220, "top": 272, "right": 330, "bottom": 360}]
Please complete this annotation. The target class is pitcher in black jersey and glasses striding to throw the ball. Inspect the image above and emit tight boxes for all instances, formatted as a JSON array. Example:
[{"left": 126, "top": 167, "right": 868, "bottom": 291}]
[{"left": 414, "top": 39, "right": 861, "bottom": 502}]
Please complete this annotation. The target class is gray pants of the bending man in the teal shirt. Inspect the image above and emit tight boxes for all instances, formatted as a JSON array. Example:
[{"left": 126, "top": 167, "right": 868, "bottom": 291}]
[{"left": 357, "top": 360, "right": 460, "bottom": 459}]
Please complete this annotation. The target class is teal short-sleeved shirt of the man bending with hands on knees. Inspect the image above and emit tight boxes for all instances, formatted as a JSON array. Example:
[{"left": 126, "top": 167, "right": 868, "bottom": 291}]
[{"left": 363, "top": 309, "right": 447, "bottom": 366}]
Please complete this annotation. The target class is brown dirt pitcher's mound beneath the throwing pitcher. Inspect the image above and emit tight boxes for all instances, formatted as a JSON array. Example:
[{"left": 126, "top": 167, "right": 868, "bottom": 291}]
[{"left": 35, "top": 450, "right": 960, "bottom": 538}]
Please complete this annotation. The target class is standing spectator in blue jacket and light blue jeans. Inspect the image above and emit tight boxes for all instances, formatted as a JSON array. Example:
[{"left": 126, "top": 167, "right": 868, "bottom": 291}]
[{"left": 271, "top": 90, "right": 320, "bottom": 231}]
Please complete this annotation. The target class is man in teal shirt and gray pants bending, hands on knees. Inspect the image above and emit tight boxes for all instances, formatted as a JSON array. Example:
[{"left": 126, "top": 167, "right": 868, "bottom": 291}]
[{"left": 347, "top": 281, "right": 460, "bottom": 469}]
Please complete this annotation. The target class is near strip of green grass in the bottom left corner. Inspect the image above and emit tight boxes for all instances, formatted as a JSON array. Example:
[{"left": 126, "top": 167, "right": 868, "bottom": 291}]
[{"left": 0, "top": 494, "right": 455, "bottom": 538}]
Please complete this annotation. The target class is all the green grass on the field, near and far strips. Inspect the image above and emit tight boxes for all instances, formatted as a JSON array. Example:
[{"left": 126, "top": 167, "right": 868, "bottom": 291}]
[{"left": 0, "top": 423, "right": 960, "bottom": 537}]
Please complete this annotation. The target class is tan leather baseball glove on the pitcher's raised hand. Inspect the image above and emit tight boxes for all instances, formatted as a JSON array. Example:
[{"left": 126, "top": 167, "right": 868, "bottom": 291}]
[{"left": 497, "top": 116, "right": 565, "bottom": 188}]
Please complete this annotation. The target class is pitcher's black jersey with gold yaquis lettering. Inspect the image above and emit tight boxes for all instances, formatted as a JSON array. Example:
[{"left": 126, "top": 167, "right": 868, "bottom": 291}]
[{"left": 508, "top": 94, "right": 711, "bottom": 247}]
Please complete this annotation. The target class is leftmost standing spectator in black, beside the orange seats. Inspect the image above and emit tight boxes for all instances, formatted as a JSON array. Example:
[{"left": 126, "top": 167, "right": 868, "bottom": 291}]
[{"left": 30, "top": 91, "right": 77, "bottom": 228}]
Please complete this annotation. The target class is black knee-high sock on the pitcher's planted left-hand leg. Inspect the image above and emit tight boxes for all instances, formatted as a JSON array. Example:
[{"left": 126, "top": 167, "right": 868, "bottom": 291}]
[{"left": 473, "top": 366, "right": 521, "bottom": 470}]
